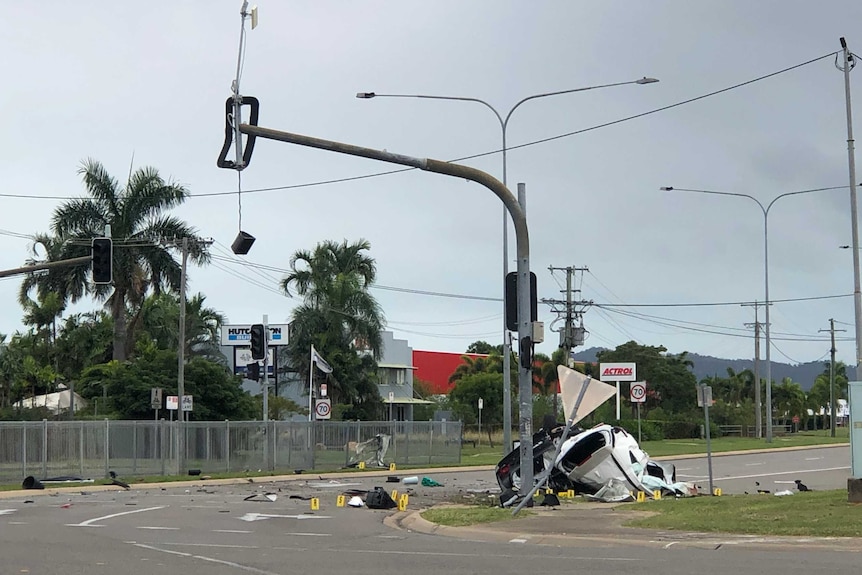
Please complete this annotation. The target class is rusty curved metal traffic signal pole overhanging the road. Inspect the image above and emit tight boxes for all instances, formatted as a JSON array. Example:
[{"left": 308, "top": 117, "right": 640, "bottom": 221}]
[{"left": 240, "top": 124, "right": 533, "bottom": 494}]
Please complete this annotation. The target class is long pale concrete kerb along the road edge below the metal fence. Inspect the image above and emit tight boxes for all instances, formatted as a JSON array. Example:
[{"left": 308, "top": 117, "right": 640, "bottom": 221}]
[{"left": 0, "top": 465, "right": 494, "bottom": 499}]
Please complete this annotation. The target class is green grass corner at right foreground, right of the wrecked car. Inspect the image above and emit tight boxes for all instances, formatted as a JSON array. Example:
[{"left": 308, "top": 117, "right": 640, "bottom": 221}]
[{"left": 618, "top": 490, "right": 862, "bottom": 537}]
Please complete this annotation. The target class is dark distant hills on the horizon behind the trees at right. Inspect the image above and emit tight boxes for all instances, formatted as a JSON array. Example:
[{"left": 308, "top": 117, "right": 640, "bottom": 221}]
[{"left": 573, "top": 347, "right": 854, "bottom": 391}]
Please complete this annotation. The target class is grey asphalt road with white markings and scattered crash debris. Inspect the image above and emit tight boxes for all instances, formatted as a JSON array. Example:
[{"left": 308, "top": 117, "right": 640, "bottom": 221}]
[{"left": 0, "top": 448, "right": 858, "bottom": 575}]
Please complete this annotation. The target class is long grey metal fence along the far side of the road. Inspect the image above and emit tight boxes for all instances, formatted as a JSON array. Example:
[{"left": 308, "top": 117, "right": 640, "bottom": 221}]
[{"left": 0, "top": 420, "right": 461, "bottom": 482}]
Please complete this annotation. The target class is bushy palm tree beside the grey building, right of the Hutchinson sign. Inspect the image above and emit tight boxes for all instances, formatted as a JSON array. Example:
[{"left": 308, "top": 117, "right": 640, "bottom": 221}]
[{"left": 281, "top": 240, "right": 384, "bottom": 418}]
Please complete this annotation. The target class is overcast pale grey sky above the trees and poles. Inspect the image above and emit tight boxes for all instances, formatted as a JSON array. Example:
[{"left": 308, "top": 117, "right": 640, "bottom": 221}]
[{"left": 0, "top": 0, "right": 862, "bottom": 364}]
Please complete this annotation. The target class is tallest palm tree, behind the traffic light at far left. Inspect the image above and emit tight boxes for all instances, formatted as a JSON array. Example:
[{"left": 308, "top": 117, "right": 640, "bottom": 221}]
[{"left": 52, "top": 160, "right": 209, "bottom": 361}]
